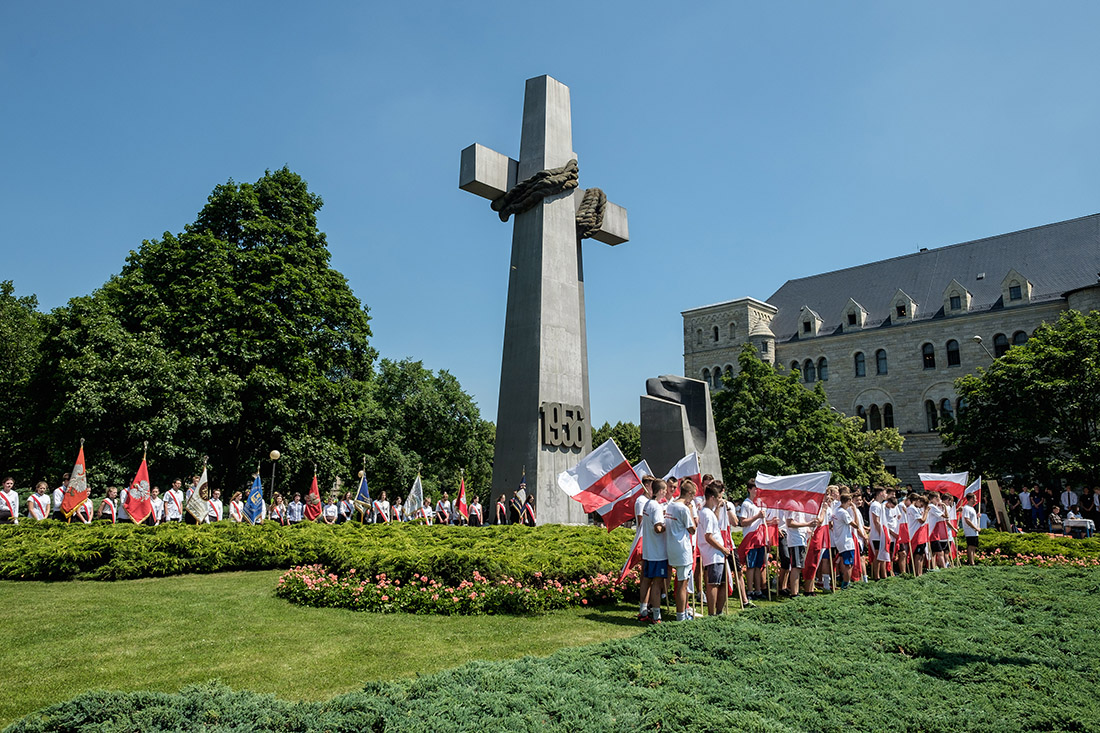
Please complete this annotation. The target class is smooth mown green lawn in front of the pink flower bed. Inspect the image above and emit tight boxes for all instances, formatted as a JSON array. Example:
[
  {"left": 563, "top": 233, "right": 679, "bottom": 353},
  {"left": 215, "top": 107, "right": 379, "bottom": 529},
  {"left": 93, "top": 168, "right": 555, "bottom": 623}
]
[{"left": 0, "top": 571, "right": 641, "bottom": 726}]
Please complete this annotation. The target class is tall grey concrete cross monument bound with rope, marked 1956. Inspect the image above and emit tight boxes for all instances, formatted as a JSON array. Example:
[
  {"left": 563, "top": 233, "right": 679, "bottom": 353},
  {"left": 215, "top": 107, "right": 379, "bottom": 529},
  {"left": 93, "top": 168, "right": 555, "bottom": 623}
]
[{"left": 459, "top": 76, "right": 628, "bottom": 524}]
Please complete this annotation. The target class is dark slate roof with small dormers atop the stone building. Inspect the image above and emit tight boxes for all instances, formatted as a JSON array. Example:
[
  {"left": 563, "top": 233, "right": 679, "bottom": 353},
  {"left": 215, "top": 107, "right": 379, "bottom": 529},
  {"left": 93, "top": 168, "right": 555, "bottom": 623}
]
[{"left": 768, "top": 214, "right": 1100, "bottom": 341}]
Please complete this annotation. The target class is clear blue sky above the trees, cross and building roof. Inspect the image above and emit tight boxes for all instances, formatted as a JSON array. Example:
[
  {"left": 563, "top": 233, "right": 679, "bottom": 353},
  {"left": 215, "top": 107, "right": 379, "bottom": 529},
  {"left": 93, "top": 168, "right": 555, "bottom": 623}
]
[{"left": 0, "top": 0, "right": 1100, "bottom": 424}]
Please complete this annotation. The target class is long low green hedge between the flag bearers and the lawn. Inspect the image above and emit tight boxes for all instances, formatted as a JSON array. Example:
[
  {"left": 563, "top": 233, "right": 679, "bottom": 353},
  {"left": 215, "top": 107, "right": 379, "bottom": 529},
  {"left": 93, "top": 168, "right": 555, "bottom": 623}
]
[{"left": 0, "top": 519, "right": 634, "bottom": 584}]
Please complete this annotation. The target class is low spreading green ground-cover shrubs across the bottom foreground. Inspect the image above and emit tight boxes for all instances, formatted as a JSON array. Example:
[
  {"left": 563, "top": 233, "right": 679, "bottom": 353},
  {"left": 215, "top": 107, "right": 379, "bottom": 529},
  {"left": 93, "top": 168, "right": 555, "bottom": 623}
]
[{"left": 8, "top": 567, "right": 1100, "bottom": 733}]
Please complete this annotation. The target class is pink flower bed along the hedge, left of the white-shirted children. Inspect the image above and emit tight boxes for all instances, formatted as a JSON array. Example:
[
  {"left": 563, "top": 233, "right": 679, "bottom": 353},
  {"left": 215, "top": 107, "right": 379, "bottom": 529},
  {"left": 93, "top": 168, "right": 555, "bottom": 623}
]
[{"left": 275, "top": 565, "right": 637, "bottom": 615}]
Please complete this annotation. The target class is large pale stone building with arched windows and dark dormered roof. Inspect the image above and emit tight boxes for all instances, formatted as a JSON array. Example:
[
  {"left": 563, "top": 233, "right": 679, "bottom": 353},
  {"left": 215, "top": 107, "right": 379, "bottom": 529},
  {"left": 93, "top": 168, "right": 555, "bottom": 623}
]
[{"left": 682, "top": 215, "right": 1100, "bottom": 484}]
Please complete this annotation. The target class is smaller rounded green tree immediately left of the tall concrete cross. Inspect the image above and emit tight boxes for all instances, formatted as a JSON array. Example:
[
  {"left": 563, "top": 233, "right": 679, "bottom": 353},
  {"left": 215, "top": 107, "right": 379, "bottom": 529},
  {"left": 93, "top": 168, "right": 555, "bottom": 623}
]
[{"left": 363, "top": 359, "right": 495, "bottom": 501}]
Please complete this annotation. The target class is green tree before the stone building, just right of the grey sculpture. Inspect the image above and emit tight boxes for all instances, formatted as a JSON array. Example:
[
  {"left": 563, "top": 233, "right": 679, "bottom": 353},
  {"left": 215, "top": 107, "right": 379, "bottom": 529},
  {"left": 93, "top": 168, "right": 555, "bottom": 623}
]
[{"left": 713, "top": 344, "right": 902, "bottom": 486}]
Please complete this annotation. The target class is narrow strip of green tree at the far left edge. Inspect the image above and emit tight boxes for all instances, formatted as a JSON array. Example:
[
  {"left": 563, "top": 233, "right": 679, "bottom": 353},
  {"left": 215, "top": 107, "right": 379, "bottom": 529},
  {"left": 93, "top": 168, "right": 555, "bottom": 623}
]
[{"left": 0, "top": 280, "right": 47, "bottom": 479}]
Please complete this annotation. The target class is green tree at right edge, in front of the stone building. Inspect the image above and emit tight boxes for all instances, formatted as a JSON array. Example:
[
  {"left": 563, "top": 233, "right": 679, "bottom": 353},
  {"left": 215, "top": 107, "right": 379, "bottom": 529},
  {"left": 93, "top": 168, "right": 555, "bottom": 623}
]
[{"left": 941, "top": 310, "right": 1100, "bottom": 485}]
